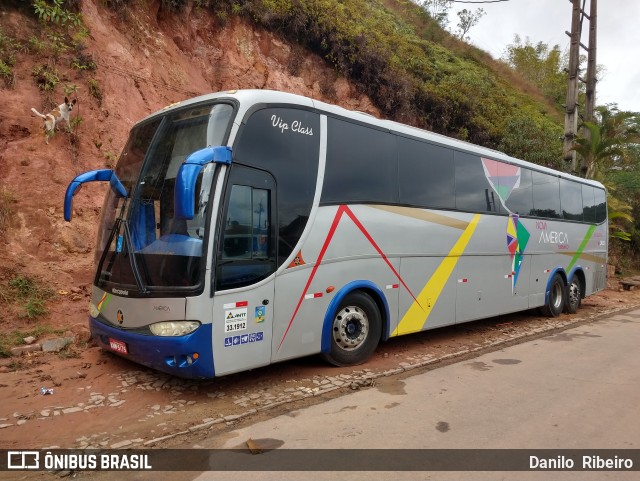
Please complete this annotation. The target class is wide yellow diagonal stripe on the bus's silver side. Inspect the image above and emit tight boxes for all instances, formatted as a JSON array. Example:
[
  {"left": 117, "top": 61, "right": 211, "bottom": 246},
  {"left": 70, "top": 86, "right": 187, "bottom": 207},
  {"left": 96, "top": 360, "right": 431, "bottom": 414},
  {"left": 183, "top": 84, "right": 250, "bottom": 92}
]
[{"left": 391, "top": 214, "right": 480, "bottom": 337}]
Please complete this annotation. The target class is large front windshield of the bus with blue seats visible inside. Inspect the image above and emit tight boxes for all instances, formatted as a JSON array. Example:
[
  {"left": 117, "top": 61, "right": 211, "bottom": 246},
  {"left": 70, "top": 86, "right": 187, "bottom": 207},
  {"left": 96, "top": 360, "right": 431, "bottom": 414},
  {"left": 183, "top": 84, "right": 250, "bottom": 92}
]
[{"left": 96, "top": 104, "right": 233, "bottom": 295}]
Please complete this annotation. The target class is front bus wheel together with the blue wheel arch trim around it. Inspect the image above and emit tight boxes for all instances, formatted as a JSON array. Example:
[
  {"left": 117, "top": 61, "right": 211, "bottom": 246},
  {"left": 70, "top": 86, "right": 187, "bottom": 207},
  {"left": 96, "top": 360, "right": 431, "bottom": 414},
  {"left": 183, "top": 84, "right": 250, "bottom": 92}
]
[{"left": 322, "top": 286, "right": 388, "bottom": 366}]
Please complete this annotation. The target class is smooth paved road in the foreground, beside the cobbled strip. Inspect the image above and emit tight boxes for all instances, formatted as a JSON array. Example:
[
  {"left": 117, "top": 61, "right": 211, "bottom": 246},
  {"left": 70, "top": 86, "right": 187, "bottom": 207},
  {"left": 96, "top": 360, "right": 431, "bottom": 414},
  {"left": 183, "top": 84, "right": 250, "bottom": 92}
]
[{"left": 192, "top": 310, "right": 640, "bottom": 481}]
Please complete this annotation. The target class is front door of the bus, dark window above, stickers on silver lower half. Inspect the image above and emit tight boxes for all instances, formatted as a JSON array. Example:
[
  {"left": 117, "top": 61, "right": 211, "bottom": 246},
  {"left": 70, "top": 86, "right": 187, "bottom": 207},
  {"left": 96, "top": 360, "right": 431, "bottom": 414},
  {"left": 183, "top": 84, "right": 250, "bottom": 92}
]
[{"left": 213, "top": 165, "right": 276, "bottom": 375}]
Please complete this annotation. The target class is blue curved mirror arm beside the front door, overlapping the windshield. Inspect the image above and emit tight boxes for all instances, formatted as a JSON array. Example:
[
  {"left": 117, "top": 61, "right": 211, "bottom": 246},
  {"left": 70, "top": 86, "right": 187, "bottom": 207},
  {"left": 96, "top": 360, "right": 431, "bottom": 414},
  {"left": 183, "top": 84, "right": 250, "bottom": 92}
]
[{"left": 174, "top": 146, "right": 232, "bottom": 220}]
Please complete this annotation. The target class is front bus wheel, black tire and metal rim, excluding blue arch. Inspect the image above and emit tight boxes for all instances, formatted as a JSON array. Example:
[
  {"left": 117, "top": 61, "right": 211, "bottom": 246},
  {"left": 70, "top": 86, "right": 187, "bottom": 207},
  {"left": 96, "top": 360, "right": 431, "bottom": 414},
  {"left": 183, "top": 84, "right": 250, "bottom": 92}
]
[{"left": 323, "top": 291, "right": 382, "bottom": 366}]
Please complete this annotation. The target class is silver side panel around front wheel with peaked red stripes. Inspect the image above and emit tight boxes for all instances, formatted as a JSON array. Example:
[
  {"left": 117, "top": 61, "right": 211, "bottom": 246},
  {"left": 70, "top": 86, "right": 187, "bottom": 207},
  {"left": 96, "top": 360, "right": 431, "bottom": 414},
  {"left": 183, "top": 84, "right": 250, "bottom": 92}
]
[{"left": 272, "top": 206, "right": 401, "bottom": 361}]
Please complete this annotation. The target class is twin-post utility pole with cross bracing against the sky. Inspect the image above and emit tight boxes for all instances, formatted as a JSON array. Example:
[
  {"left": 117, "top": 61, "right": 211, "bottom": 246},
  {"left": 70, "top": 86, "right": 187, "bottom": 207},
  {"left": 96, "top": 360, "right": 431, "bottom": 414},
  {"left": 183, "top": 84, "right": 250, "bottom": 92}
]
[{"left": 563, "top": 0, "right": 597, "bottom": 175}]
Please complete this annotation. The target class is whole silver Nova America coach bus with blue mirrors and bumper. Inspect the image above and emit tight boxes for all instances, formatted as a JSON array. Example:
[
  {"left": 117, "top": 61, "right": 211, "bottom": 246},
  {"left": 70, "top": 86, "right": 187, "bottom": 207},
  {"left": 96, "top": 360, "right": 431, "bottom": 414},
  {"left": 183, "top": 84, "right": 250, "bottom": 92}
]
[{"left": 65, "top": 90, "right": 608, "bottom": 378}]
